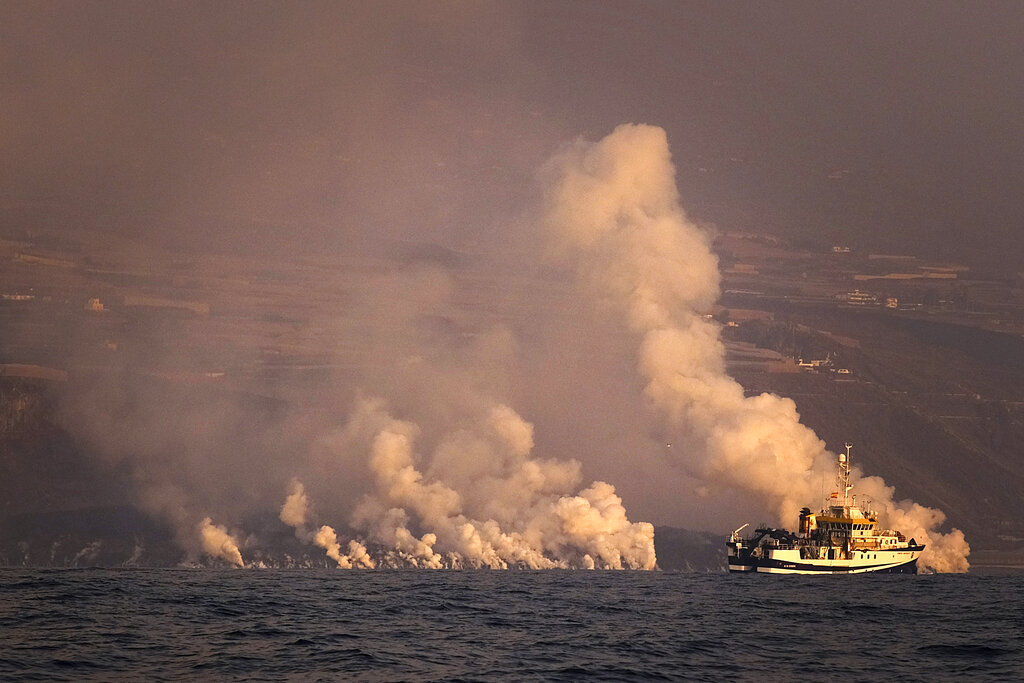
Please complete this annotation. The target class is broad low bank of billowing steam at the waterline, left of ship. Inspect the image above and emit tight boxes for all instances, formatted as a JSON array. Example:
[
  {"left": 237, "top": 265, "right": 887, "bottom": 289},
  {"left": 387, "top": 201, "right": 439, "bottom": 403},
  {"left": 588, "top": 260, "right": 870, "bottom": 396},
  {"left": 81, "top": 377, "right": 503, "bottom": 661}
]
[{"left": 349, "top": 399, "right": 656, "bottom": 569}]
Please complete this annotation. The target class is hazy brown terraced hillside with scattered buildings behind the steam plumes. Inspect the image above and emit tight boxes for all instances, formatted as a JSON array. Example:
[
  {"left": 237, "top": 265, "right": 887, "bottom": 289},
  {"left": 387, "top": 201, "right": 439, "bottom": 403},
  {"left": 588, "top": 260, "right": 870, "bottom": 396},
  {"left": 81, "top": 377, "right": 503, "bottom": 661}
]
[{"left": 2, "top": 145, "right": 1024, "bottom": 566}]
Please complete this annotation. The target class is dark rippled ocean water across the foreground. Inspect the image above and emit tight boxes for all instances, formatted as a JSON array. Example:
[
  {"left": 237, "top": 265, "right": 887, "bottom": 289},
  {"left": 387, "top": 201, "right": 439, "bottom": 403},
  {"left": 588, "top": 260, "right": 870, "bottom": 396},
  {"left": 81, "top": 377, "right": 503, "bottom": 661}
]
[{"left": 0, "top": 569, "right": 1024, "bottom": 681}]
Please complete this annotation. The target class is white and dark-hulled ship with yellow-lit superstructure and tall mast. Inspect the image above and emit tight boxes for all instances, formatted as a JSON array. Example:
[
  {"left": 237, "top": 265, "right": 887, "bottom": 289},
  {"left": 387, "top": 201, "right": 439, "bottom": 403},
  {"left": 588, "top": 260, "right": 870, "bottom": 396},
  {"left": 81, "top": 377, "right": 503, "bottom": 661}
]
[{"left": 726, "top": 443, "right": 925, "bottom": 574}]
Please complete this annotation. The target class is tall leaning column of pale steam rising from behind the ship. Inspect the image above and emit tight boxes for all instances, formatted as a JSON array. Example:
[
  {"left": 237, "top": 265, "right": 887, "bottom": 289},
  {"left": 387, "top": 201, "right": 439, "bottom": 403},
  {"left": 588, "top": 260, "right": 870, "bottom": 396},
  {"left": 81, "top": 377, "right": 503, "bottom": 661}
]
[{"left": 544, "top": 125, "right": 970, "bottom": 571}]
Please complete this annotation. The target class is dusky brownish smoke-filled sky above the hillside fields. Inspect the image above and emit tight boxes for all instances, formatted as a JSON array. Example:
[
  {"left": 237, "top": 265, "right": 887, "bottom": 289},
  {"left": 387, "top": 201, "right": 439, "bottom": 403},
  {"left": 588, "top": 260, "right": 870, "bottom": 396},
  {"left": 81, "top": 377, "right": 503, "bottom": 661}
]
[{"left": 0, "top": 1, "right": 1024, "bottom": 265}]
